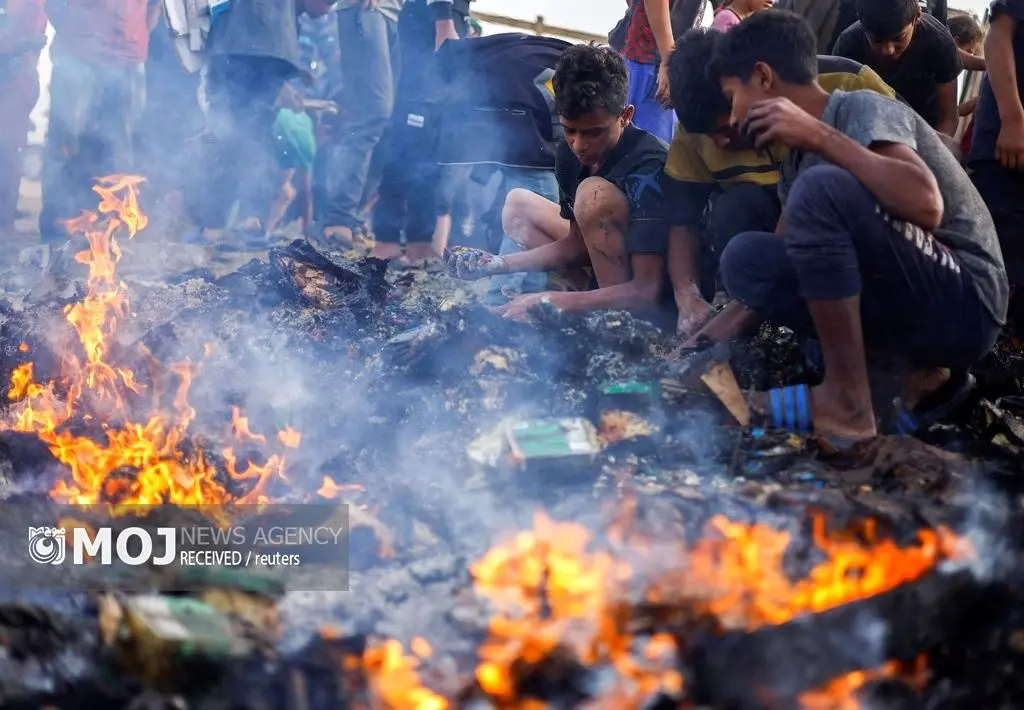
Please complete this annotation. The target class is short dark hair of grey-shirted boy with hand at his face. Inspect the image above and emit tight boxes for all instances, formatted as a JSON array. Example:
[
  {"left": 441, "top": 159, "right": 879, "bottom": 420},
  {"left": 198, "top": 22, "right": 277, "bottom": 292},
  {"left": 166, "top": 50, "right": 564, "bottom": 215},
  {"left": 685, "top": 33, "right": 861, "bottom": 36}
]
[{"left": 711, "top": 10, "right": 818, "bottom": 85}]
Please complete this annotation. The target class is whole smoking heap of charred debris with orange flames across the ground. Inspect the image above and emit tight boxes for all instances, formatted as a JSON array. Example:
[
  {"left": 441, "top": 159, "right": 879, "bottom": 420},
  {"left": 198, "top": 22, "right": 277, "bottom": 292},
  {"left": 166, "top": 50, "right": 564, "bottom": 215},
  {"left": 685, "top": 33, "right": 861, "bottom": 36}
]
[{"left": 0, "top": 177, "right": 1024, "bottom": 710}]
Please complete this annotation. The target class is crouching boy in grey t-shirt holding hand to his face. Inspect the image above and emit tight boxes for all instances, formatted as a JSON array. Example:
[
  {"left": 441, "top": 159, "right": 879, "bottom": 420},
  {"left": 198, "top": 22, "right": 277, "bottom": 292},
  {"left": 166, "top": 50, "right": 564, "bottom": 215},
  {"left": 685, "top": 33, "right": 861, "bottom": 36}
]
[{"left": 688, "top": 10, "right": 1008, "bottom": 444}]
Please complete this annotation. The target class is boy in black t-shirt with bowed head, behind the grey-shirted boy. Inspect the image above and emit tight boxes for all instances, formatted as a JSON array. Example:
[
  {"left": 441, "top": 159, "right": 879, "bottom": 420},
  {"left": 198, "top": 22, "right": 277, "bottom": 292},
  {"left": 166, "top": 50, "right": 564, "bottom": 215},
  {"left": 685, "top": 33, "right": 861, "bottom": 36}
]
[{"left": 833, "top": 0, "right": 964, "bottom": 136}]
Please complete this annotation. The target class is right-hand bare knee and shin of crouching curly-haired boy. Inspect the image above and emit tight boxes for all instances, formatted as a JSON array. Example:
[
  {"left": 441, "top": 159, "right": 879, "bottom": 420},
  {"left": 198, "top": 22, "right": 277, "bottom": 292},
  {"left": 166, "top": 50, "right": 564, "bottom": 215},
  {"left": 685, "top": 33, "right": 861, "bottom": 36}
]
[{"left": 573, "top": 177, "right": 633, "bottom": 288}]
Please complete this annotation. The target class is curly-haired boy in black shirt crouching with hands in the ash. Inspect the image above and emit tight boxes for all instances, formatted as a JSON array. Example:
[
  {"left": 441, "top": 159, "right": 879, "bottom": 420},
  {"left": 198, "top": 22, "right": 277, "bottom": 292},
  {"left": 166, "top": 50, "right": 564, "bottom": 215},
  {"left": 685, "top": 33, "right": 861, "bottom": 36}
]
[{"left": 445, "top": 45, "right": 675, "bottom": 323}]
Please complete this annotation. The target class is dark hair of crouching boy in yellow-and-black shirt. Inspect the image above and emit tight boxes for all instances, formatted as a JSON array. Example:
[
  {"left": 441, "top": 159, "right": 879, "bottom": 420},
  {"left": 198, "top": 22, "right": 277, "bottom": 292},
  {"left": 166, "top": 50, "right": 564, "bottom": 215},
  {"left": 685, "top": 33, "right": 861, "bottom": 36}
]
[{"left": 669, "top": 28, "right": 729, "bottom": 133}]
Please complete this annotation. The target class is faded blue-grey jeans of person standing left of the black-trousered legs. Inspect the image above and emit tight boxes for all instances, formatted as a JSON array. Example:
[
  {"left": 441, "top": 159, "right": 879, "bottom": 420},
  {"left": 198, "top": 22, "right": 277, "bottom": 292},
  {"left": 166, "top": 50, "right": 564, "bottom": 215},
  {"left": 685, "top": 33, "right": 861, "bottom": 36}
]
[{"left": 323, "top": 7, "right": 398, "bottom": 227}]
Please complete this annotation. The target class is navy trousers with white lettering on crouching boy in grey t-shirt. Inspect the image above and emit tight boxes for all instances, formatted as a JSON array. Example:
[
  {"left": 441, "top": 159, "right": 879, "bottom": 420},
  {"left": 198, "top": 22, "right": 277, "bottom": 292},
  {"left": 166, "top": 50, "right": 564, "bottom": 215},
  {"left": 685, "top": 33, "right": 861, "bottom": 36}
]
[{"left": 721, "top": 165, "right": 1001, "bottom": 369}]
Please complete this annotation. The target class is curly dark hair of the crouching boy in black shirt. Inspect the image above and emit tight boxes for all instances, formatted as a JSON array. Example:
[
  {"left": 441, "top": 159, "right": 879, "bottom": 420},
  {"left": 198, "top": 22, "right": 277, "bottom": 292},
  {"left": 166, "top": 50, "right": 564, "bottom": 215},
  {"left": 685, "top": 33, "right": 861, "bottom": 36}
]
[{"left": 552, "top": 43, "right": 630, "bottom": 121}]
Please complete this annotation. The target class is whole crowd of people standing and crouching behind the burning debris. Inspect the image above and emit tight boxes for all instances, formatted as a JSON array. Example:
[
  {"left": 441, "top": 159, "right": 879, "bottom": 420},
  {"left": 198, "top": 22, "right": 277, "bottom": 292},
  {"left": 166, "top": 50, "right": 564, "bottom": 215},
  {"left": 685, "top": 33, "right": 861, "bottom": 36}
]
[{"left": 0, "top": 0, "right": 1024, "bottom": 441}]
